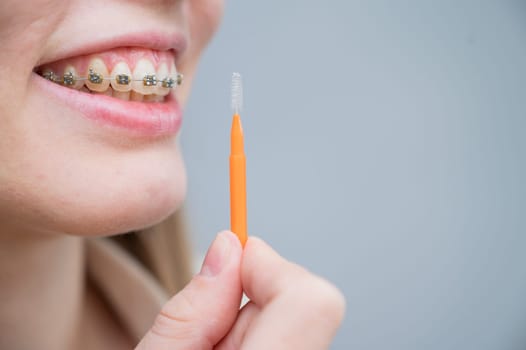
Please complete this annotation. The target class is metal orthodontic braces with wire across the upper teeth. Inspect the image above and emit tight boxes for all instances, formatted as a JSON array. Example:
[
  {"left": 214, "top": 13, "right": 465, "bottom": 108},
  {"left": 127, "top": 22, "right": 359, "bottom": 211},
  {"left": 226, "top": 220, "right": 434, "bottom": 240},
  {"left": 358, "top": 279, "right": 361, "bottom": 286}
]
[{"left": 42, "top": 68, "right": 184, "bottom": 89}]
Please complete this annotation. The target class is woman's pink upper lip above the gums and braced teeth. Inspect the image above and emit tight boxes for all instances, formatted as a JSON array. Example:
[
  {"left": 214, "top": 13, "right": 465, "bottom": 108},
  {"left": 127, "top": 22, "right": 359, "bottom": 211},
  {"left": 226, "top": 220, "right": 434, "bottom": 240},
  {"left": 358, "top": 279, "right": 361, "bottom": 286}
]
[{"left": 37, "top": 31, "right": 187, "bottom": 66}]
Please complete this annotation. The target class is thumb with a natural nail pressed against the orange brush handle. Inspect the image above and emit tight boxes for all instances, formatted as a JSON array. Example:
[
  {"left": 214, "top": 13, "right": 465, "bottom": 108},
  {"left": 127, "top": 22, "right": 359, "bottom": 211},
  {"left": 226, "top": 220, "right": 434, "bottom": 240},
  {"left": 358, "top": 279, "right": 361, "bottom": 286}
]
[{"left": 136, "top": 231, "right": 242, "bottom": 350}]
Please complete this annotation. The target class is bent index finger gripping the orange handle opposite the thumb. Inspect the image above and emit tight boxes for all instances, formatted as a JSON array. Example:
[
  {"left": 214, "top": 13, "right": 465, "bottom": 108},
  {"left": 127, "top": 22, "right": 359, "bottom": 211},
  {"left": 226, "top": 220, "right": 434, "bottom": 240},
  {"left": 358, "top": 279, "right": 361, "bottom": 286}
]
[{"left": 239, "top": 238, "right": 345, "bottom": 350}]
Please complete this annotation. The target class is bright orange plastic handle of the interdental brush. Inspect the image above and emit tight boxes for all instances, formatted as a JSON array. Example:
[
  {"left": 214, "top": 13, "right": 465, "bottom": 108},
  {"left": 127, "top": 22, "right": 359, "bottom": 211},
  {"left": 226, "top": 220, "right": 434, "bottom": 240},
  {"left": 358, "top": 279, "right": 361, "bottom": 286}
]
[{"left": 230, "top": 114, "right": 248, "bottom": 246}]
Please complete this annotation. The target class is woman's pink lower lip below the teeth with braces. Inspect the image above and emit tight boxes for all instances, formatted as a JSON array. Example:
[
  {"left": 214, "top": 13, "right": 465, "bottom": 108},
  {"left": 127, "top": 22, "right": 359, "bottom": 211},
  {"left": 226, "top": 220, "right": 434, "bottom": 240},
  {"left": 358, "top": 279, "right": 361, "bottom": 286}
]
[{"left": 32, "top": 73, "right": 182, "bottom": 138}]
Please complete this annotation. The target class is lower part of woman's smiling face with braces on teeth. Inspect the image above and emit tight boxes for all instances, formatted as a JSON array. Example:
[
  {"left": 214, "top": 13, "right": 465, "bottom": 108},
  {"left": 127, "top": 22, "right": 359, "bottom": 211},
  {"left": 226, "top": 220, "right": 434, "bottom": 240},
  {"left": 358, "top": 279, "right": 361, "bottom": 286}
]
[{"left": 0, "top": 0, "right": 223, "bottom": 235}]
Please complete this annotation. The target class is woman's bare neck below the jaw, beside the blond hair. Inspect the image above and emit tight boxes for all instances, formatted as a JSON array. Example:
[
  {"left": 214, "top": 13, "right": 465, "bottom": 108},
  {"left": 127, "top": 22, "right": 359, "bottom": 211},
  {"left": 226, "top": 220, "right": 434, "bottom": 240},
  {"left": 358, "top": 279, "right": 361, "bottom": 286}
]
[{"left": 0, "top": 230, "right": 84, "bottom": 350}]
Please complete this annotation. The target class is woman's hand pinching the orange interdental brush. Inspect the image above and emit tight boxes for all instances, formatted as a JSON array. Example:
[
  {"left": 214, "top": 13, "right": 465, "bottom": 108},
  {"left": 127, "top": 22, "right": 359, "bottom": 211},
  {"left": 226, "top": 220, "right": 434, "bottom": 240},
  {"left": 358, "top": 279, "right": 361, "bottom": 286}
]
[{"left": 136, "top": 231, "right": 345, "bottom": 350}]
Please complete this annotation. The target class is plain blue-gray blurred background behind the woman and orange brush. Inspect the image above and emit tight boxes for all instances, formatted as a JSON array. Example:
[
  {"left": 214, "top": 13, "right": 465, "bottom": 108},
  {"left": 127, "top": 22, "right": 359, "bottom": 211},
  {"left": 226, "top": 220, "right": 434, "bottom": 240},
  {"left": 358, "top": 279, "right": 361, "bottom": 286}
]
[{"left": 182, "top": 0, "right": 526, "bottom": 350}]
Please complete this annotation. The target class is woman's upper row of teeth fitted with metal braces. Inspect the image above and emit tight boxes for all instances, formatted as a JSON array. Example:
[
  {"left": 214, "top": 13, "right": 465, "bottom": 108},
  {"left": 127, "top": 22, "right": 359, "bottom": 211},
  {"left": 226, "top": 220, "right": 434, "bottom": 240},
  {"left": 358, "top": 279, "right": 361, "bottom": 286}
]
[{"left": 42, "top": 58, "right": 183, "bottom": 96}]
